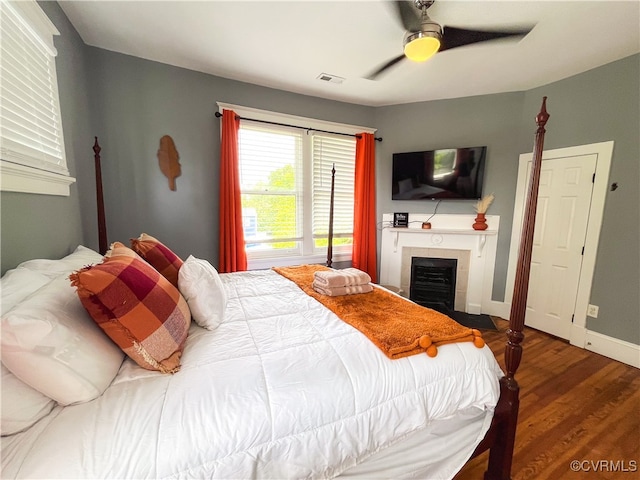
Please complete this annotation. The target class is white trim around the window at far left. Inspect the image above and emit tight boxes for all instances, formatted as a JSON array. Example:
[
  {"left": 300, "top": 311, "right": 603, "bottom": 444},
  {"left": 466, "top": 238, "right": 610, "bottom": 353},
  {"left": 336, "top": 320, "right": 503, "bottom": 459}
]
[{"left": 0, "top": 0, "right": 76, "bottom": 196}]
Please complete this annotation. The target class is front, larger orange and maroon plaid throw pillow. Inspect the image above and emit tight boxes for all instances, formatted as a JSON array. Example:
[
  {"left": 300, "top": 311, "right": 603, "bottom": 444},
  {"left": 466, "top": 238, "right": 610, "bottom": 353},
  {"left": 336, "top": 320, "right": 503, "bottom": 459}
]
[{"left": 69, "top": 242, "right": 191, "bottom": 373}]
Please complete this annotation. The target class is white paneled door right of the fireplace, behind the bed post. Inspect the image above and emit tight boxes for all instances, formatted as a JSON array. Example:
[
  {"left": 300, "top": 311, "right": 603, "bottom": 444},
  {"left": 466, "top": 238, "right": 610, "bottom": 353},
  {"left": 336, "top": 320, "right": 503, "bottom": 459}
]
[{"left": 522, "top": 154, "right": 597, "bottom": 339}]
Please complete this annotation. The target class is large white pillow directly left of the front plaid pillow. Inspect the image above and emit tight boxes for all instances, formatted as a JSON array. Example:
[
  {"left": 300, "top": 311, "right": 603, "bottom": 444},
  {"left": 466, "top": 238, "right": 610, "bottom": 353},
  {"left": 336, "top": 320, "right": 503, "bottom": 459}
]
[{"left": 0, "top": 275, "right": 124, "bottom": 405}]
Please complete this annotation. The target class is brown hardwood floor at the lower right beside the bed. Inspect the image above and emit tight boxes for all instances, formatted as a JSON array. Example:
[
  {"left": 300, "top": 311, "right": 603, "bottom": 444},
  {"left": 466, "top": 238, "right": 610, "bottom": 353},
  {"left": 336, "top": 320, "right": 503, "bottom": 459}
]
[{"left": 455, "top": 317, "right": 640, "bottom": 480}]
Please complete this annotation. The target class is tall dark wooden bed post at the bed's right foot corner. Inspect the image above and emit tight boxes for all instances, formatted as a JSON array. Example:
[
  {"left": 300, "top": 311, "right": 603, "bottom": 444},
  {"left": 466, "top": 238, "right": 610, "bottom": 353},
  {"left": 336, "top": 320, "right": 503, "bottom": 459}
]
[{"left": 477, "top": 97, "right": 549, "bottom": 480}]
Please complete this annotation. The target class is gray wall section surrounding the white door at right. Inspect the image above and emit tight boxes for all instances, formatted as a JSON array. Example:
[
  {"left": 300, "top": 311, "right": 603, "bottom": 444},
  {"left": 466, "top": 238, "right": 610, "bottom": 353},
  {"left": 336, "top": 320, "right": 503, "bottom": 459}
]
[{"left": 521, "top": 55, "right": 640, "bottom": 344}]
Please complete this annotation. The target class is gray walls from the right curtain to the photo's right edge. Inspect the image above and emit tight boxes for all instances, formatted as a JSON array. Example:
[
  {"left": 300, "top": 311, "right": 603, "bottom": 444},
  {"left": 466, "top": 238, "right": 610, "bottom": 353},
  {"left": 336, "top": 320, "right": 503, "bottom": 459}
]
[{"left": 375, "top": 55, "right": 640, "bottom": 344}]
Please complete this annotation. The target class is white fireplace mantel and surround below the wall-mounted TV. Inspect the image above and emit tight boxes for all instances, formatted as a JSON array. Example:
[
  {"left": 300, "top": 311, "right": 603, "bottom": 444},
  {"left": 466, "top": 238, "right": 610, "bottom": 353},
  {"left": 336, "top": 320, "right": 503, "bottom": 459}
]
[{"left": 380, "top": 213, "right": 500, "bottom": 314}]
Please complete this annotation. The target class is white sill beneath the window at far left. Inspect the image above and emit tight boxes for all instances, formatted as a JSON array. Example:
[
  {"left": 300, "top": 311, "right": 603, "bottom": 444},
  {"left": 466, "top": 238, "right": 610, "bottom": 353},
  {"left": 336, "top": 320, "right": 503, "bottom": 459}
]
[{"left": 0, "top": 160, "right": 76, "bottom": 197}]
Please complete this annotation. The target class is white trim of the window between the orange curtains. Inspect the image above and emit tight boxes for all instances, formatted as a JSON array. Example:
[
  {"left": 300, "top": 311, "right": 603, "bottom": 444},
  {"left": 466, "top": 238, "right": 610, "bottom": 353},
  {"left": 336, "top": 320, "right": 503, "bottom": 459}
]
[{"left": 216, "top": 102, "right": 376, "bottom": 270}]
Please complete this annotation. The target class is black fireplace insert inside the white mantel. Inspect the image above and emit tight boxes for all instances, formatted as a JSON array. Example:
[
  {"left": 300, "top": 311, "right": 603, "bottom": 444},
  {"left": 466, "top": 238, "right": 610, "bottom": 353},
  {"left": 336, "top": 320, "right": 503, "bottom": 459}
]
[{"left": 409, "top": 257, "right": 458, "bottom": 314}]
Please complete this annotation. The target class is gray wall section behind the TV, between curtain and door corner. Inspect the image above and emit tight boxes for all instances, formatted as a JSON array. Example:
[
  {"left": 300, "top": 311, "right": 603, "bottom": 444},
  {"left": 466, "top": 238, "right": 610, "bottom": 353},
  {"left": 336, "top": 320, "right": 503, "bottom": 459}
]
[{"left": 375, "top": 93, "right": 528, "bottom": 301}]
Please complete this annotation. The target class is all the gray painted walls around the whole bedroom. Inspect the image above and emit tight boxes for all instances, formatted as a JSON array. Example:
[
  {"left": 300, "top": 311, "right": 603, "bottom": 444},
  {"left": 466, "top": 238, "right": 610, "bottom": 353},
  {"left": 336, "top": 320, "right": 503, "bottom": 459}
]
[{"left": 1, "top": 2, "right": 640, "bottom": 344}]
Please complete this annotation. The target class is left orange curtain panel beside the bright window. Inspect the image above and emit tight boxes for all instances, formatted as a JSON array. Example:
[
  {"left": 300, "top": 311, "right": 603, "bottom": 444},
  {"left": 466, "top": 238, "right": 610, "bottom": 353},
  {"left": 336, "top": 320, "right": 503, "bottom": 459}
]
[{"left": 218, "top": 110, "right": 247, "bottom": 273}]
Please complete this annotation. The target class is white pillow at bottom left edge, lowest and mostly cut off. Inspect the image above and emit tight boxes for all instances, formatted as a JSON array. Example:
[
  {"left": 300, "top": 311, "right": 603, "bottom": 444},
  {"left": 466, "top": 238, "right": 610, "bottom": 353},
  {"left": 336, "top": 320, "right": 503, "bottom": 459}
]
[{"left": 0, "top": 364, "right": 56, "bottom": 437}]
